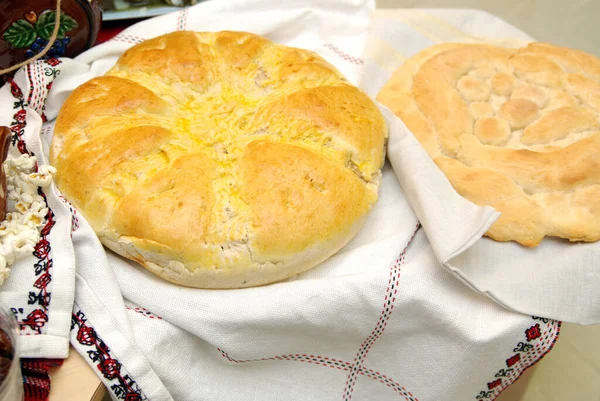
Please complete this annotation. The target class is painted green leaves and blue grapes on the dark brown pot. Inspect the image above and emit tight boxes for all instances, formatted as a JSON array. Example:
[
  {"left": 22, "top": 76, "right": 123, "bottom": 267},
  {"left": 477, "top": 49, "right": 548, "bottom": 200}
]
[{"left": 2, "top": 10, "right": 78, "bottom": 58}]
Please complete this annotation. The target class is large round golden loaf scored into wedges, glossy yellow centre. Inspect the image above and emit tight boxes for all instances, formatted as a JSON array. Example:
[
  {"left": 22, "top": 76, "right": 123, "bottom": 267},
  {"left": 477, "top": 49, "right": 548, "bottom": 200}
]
[{"left": 50, "top": 31, "right": 387, "bottom": 288}]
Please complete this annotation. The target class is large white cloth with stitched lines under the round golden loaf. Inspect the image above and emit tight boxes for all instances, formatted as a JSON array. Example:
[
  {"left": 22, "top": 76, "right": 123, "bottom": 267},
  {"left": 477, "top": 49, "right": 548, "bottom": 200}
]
[{"left": 0, "top": 0, "right": 560, "bottom": 401}]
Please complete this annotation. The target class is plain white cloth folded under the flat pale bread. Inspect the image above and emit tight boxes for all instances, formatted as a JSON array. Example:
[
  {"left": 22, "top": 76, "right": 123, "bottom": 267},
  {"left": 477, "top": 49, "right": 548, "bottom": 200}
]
[{"left": 362, "top": 10, "right": 600, "bottom": 324}]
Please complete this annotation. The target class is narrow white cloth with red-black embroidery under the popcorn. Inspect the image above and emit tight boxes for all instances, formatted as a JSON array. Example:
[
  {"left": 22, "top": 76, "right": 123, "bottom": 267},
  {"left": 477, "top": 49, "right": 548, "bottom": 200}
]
[{"left": 0, "top": 69, "right": 75, "bottom": 358}]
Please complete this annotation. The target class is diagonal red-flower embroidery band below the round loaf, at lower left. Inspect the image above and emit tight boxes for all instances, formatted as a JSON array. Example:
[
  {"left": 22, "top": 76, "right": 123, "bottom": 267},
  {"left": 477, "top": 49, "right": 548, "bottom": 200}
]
[{"left": 71, "top": 310, "right": 148, "bottom": 401}]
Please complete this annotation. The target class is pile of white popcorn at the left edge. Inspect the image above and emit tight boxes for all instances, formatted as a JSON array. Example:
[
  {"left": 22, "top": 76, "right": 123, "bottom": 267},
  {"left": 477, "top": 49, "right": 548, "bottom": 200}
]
[{"left": 0, "top": 154, "right": 56, "bottom": 285}]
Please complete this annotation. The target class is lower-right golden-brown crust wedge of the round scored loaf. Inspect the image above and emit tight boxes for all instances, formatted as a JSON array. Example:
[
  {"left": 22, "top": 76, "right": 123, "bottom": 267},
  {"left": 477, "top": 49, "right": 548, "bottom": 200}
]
[{"left": 241, "top": 141, "right": 376, "bottom": 261}]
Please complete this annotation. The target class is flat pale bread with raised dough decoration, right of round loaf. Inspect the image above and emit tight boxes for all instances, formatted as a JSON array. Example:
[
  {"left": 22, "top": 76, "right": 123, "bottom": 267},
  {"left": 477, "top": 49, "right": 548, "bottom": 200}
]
[{"left": 378, "top": 43, "right": 600, "bottom": 246}]
